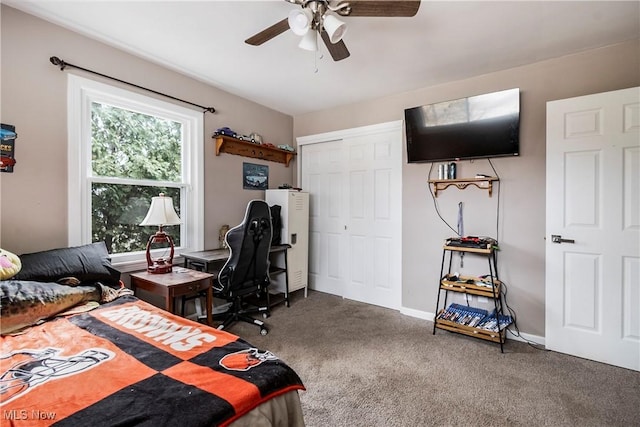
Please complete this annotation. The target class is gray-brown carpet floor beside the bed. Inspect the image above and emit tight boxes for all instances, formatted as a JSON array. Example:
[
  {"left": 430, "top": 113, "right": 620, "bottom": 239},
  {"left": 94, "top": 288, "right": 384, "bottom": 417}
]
[{"left": 229, "top": 291, "right": 640, "bottom": 427}]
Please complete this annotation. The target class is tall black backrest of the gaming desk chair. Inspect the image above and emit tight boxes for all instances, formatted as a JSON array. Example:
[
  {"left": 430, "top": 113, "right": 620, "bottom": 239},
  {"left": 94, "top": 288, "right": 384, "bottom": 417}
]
[{"left": 216, "top": 200, "right": 272, "bottom": 296}]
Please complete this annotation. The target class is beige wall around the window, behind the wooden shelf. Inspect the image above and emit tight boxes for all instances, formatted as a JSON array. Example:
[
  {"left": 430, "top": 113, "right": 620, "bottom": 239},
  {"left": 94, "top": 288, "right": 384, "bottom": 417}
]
[{"left": 0, "top": 5, "right": 296, "bottom": 253}]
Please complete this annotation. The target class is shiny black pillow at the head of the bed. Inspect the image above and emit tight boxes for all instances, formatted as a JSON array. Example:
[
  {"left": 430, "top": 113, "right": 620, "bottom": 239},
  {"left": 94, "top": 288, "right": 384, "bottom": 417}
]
[{"left": 13, "top": 242, "right": 120, "bottom": 286}]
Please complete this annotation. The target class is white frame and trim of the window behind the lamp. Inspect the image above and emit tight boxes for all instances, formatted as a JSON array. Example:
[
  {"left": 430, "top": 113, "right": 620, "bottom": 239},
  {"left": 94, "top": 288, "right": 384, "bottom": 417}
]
[{"left": 67, "top": 74, "right": 204, "bottom": 271}]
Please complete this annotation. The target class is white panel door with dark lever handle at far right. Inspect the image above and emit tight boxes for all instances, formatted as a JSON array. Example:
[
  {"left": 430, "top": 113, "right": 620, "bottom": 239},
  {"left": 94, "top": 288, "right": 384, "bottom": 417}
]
[{"left": 545, "top": 88, "right": 640, "bottom": 370}]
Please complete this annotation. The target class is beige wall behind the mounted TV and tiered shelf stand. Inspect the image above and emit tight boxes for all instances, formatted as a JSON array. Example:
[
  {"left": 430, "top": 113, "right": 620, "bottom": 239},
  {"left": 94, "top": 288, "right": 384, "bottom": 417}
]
[{"left": 294, "top": 40, "right": 640, "bottom": 342}]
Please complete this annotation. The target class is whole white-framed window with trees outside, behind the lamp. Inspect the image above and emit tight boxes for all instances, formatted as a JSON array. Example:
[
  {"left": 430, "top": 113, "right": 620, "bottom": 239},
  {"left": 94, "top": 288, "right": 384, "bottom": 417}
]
[{"left": 68, "top": 75, "right": 203, "bottom": 264}]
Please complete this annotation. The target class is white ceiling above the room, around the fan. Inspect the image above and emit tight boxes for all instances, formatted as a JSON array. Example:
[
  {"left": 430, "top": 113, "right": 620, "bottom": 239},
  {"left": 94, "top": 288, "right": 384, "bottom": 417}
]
[{"left": 2, "top": 0, "right": 640, "bottom": 116}]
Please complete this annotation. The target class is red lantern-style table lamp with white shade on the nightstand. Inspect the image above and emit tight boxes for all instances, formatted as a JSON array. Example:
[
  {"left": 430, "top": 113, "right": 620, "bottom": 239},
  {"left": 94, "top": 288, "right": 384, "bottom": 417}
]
[{"left": 140, "top": 193, "right": 180, "bottom": 274}]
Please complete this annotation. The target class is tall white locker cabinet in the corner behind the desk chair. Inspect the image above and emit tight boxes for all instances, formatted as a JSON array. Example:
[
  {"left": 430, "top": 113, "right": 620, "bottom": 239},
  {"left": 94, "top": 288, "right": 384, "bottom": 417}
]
[{"left": 265, "top": 190, "right": 309, "bottom": 297}]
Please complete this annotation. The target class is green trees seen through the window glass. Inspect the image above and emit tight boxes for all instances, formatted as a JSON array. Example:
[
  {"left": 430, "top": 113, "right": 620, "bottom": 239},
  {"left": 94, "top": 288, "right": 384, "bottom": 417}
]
[{"left": 91, "top": 102, "right": 183, "bottom": 253}]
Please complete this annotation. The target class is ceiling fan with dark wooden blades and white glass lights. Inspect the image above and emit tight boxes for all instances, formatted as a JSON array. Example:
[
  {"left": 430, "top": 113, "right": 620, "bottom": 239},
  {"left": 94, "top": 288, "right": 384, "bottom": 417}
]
[{"left": 245, "top": 0, "right": 420, "bottom": 61}]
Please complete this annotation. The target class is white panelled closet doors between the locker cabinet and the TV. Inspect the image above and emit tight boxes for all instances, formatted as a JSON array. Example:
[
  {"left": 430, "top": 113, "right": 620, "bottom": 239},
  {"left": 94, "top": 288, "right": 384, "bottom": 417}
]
[{"left": 298, "top": 122, "right": 402, "bottom": 309}]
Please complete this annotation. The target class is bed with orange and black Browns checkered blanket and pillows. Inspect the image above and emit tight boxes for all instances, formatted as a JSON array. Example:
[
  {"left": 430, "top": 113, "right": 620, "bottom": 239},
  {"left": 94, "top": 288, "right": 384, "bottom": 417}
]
[{"left": 0, "top": 247, "right": 304, "bottom": 426}]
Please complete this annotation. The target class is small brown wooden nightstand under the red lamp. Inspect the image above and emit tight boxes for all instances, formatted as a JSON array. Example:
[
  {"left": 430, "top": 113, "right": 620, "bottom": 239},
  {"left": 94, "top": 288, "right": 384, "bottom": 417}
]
[{"left": 131, "top": 267, "right": 215, "bottom": 326}]
